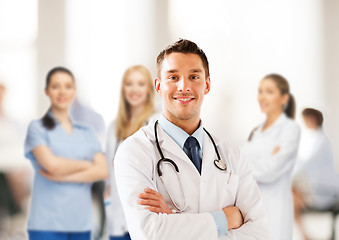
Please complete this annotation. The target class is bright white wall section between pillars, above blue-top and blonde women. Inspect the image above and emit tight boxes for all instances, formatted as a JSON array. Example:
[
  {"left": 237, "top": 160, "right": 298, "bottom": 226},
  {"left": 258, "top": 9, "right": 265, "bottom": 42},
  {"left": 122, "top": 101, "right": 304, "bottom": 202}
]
[{"left": 66, "top": 0, "right": 161, "bottom": 124}]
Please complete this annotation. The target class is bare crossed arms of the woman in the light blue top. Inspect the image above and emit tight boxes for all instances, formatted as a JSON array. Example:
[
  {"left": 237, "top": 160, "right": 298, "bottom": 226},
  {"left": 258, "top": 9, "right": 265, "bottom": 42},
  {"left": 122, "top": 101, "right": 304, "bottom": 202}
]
[{"left": 33, "top": 145, "right": 108, "bottom": 182}]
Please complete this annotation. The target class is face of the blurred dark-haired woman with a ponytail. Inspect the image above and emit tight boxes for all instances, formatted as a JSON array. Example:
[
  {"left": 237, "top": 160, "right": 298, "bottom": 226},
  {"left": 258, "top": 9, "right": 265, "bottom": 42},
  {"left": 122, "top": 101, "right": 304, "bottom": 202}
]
[{"left": 258, "top": 78, "right": 288, "bottom": 114}]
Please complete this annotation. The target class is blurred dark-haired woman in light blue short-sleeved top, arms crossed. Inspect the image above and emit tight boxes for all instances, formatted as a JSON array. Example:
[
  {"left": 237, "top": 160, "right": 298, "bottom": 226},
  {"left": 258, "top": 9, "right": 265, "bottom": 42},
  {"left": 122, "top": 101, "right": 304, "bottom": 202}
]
[{"left": 25, "top": 67, "right": 108, "bottom": 240}]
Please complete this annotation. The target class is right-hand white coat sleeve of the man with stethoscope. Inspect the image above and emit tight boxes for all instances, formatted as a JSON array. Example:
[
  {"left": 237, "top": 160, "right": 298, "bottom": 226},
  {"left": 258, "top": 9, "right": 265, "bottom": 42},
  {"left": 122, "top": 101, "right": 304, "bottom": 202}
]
[{"left": 226, "top": 145, "right": 270, "bottom": 240}]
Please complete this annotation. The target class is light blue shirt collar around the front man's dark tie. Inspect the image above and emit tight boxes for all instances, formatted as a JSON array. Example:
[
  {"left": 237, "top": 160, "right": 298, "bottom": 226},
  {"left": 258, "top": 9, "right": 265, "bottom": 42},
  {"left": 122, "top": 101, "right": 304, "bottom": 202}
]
[{"left": 159, "top": 114, "right": 204, "bottom": 149}]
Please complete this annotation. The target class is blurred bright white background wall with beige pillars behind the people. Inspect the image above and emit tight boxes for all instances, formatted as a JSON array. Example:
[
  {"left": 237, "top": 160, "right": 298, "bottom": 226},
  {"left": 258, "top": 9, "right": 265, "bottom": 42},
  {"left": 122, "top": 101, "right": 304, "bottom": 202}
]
[{"left": 0, "top": 0, "right": 339, "bottom": 239}]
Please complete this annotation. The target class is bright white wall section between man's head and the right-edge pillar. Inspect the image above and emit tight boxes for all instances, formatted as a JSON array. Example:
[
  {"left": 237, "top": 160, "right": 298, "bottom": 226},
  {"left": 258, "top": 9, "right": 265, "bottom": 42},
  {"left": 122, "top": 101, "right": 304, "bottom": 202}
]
[{"left": 170, "top": 0, "right": 324, "bottom": 144}]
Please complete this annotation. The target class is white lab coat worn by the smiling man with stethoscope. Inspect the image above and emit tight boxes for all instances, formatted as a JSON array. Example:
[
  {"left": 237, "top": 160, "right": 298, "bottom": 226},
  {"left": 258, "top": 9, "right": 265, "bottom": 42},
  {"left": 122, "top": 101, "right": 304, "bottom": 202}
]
[{"left": 115, "top": 121, "right": 268, "bottom": 240}]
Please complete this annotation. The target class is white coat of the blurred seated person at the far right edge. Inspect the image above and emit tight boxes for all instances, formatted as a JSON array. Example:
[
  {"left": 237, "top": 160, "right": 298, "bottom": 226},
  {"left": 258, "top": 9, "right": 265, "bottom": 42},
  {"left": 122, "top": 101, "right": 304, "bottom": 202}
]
[{"left": 294, "top": 128, "right": 339, "bottom": 210}]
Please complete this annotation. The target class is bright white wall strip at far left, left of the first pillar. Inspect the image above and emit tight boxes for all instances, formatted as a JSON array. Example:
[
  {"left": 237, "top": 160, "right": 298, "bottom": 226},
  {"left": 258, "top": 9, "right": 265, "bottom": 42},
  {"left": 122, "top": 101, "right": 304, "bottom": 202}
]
[{"left": 0, "top": 0, "right": 38, "bottom": 122}]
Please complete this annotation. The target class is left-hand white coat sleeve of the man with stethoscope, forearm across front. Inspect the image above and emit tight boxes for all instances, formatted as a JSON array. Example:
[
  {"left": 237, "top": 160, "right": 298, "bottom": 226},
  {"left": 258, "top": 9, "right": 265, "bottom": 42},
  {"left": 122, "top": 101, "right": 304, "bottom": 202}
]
[{"left": 112, "top": 131, "right": 218, "bottom": 240}]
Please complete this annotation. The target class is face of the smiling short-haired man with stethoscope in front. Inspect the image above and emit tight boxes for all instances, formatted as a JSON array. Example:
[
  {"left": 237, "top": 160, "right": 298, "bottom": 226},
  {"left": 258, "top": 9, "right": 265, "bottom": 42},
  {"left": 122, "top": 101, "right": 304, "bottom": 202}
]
[{"left": 155, "top": 53, "right": 210, "bottom": 123}]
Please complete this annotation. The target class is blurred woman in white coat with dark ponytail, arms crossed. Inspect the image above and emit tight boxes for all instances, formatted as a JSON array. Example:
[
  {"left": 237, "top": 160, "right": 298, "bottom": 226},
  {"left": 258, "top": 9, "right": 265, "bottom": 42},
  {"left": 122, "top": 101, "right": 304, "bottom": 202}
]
[{"left": 243, "top": 74, "right": 300, "bottom": 240}]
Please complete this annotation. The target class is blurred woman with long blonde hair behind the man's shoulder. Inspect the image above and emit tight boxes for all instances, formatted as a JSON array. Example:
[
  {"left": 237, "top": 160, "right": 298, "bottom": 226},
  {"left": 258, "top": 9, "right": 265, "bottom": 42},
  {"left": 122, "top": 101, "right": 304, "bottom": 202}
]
[{"left": 106, "top": 65, "right": 155, "bottom": 240}]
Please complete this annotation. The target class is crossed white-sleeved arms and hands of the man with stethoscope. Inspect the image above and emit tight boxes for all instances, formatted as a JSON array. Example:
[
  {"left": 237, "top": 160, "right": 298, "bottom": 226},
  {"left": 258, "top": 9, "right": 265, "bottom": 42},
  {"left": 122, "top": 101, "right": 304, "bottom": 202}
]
[{"left": 114, "top": 137, "right": 269, "bottom": 240}]
